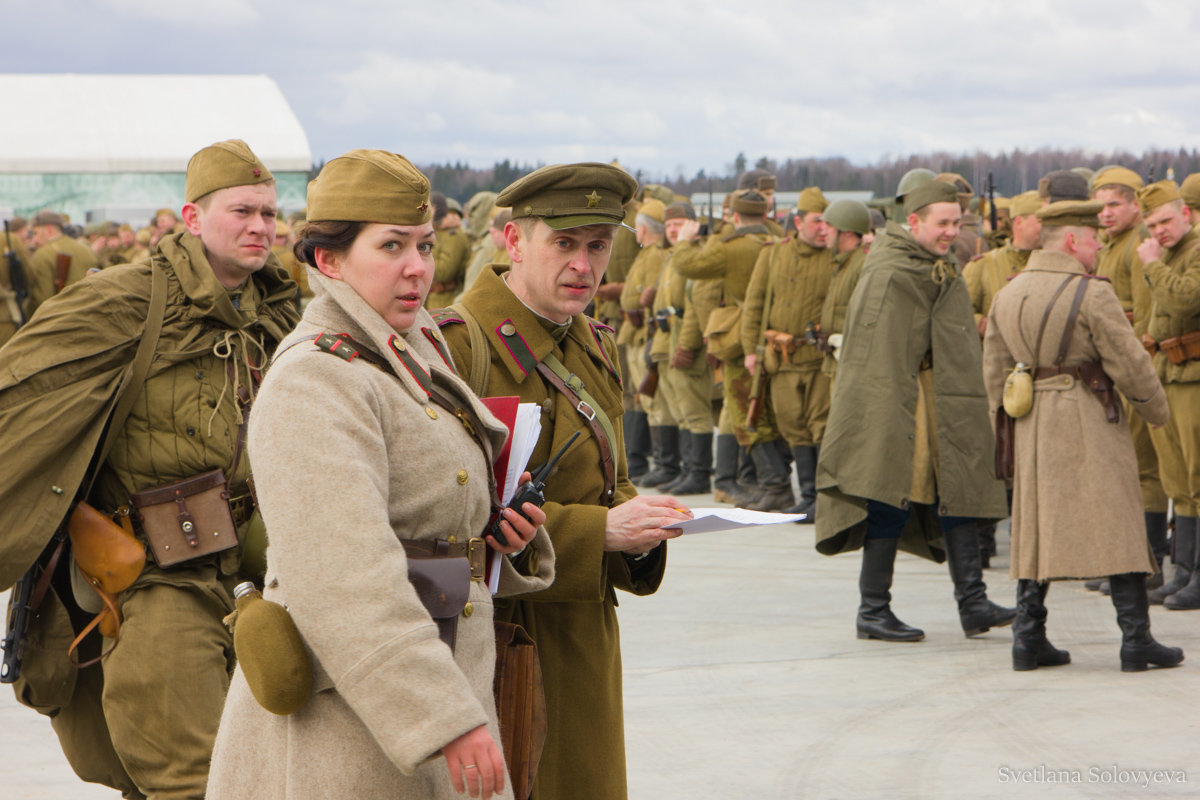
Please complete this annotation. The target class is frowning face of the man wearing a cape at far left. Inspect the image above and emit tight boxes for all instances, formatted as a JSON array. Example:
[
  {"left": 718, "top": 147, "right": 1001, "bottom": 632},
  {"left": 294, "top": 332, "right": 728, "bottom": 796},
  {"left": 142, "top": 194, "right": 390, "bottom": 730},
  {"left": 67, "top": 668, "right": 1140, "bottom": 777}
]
[{"left": 184, "top": 184, "right": 277, "bottom": 289}]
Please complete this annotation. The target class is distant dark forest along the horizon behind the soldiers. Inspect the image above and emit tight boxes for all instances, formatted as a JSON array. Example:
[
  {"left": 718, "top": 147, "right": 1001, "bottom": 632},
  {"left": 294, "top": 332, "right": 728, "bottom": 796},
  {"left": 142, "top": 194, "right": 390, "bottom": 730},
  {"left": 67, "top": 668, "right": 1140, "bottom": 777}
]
[{"left": 391, "top": 148, "right": 1200, "bottom": 203}]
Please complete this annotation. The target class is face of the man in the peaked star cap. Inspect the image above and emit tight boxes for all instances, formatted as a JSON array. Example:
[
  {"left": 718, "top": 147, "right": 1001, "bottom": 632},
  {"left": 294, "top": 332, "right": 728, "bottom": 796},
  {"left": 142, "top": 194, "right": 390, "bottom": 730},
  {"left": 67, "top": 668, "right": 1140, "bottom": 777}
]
[{"left": 504, "top": 219, "right": 616, "bottom": 323}]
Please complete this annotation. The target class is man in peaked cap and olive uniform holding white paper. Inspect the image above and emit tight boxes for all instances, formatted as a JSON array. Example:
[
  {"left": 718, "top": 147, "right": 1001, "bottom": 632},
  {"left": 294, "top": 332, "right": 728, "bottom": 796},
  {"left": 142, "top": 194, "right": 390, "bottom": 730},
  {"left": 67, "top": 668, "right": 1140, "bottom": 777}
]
[{"left": 438, "top": 163, "right": 688, "bottom": 800}]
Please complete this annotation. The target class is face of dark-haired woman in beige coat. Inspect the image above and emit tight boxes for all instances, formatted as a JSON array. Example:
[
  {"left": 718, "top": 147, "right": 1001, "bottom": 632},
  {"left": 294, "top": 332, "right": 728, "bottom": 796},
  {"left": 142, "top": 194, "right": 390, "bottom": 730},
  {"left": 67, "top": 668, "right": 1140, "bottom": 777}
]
[{"left": 317, "top": 222, "right": 434, "bottom": 333}]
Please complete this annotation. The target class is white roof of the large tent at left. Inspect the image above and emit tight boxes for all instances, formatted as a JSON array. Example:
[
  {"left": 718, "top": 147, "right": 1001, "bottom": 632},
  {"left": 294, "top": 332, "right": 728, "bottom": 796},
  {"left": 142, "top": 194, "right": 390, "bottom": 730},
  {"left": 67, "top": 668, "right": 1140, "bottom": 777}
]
[{"left": 0, "top": 74, "right": 312, "bottom": 173}]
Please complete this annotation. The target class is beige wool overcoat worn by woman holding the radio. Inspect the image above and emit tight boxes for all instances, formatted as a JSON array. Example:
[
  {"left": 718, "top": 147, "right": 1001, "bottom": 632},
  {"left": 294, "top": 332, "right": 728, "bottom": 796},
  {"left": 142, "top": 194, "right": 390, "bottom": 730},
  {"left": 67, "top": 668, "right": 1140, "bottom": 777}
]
[{"left": 208, "top": 269, "right": 553, "bottom": 800}]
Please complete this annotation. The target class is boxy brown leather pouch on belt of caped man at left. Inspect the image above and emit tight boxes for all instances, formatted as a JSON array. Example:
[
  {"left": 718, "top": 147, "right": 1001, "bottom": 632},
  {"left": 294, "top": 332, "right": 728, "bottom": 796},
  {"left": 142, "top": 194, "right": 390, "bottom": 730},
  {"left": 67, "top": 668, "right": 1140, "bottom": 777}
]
[{"left": 131, "top": 469, "right": 238, "bottom": 567}]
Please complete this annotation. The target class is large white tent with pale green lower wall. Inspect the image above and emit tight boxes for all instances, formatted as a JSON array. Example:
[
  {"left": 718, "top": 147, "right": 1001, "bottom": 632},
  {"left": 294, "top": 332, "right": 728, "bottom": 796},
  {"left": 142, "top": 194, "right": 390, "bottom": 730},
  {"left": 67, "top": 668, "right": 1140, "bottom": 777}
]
[{"left": 0, "top": 74, "right": 312, "bottom": 219}]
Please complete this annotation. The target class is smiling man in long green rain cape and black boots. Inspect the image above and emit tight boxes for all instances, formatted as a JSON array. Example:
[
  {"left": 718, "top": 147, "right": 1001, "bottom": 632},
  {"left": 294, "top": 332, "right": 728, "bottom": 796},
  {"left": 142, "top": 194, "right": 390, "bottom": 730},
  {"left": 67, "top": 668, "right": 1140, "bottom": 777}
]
[{"left": 816, "top": 181, "right": 1015, "bottom": 642}]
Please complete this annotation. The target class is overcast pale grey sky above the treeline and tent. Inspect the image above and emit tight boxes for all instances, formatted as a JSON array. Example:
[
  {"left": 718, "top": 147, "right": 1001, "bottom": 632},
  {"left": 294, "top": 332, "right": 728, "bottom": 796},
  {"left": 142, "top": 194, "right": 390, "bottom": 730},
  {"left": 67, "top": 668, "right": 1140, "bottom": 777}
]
[{"left": 9, "top": 0, "right": 1200, "bottom": 176}]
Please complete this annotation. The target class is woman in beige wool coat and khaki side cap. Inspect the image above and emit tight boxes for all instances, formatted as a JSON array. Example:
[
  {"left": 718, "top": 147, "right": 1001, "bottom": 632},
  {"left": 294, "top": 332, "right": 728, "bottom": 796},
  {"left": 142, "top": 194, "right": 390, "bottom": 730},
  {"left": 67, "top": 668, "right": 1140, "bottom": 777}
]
[{"left": 209, "top": 150, "right": 553, "bottom": 800}]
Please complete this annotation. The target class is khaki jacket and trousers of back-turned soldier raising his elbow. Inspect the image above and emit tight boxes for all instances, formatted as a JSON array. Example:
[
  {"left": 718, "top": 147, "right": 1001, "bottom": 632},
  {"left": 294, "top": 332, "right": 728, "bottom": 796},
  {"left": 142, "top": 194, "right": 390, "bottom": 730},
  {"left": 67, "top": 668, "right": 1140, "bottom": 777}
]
[{"left": 672, "top": 225, "right": 778, "bottom": 447}]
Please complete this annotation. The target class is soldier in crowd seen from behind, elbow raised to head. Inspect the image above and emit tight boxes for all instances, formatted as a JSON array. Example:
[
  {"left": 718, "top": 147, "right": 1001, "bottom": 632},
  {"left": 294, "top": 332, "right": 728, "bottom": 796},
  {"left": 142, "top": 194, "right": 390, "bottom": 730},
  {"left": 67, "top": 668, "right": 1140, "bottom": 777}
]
[{"left": 671, "top": 190, "right": 796, "bottom": 511}]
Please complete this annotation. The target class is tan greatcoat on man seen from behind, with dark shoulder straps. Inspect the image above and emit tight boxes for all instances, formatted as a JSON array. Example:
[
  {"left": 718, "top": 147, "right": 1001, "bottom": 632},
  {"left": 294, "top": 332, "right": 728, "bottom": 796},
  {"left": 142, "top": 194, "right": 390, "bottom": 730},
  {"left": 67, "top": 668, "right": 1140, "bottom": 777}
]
[{"left": 984, "top": 251, "right": 1168, "bottom": 581}]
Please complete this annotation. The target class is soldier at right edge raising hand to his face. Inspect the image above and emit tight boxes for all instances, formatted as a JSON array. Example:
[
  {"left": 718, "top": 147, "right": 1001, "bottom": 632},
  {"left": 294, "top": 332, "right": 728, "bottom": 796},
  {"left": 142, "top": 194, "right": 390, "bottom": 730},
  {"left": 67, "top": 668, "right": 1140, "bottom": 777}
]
[{"left": 1135, "top": 181, "right": 1200, "bottom": 609}]
